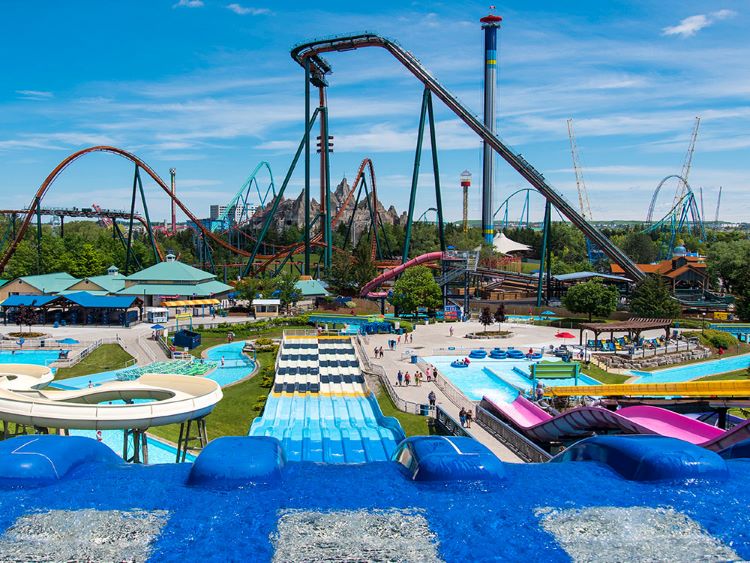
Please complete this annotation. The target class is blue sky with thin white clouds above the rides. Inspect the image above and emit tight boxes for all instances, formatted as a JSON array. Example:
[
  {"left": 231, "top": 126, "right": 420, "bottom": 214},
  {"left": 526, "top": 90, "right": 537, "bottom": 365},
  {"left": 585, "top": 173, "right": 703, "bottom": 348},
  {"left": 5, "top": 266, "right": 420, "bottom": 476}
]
[{"left": 0, "top": 0, "right": 750, "bottom": 226}]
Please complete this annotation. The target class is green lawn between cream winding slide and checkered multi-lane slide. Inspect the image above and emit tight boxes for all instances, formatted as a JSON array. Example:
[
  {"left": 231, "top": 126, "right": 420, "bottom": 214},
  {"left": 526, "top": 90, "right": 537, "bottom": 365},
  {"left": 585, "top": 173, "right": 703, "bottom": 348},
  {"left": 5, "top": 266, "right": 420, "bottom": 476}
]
[{"left": 149, "top": 352, "right": 276, "bottom": 443}]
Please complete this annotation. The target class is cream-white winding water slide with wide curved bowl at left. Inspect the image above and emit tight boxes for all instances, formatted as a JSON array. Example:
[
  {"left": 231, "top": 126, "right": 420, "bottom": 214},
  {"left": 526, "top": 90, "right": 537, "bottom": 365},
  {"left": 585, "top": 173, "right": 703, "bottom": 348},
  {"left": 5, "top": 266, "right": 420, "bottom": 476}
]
[{"left": 0, "top": 364, "right": 222, "bottom": 430}]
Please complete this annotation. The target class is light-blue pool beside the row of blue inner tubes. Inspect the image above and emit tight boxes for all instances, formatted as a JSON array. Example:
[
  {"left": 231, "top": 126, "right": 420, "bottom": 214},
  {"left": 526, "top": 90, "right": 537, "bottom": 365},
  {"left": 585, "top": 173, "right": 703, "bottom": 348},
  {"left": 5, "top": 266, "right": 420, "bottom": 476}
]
[{"left": 423, "top": 356, "right": 599, "bottom": 402}]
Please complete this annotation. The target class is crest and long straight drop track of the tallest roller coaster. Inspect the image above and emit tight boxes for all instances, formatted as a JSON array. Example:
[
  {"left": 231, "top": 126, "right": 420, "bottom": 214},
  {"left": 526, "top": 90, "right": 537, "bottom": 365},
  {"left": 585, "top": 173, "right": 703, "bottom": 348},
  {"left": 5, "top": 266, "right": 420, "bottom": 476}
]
[{"left": 291, "top": 33, "right": 645, "bottom": 280}]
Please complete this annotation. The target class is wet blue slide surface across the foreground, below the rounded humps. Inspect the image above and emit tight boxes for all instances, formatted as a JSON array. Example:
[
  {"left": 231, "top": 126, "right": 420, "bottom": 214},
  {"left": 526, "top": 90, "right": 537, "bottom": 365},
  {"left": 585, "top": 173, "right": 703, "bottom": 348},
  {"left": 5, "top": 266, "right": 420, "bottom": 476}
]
[{"left": 0, "top": 461, "right": 750, "bottom": 563}]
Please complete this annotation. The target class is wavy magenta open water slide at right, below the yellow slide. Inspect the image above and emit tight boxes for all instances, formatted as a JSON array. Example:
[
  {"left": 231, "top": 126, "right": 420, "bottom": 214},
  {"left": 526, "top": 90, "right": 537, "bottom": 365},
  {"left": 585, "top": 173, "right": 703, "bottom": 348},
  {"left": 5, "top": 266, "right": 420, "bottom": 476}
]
[{"left": 484, "top": 395, "right": 750, "bottom": 451}]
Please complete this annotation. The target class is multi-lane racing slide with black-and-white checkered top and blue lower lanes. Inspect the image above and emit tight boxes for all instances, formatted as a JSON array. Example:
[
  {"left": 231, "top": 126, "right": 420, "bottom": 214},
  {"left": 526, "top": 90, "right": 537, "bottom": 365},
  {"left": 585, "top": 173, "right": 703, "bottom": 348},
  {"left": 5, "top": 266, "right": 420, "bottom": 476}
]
[{"left": 249, "top": 336, "right": 404, "bottom": 463}]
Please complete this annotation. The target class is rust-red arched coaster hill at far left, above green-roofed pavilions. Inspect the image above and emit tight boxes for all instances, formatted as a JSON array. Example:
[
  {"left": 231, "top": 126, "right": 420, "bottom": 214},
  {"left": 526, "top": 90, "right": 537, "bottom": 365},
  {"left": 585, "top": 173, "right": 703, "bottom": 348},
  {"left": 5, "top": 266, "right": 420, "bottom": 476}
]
[{"left": 0, "top": 145, "right": 258, "bottom": 272}]
